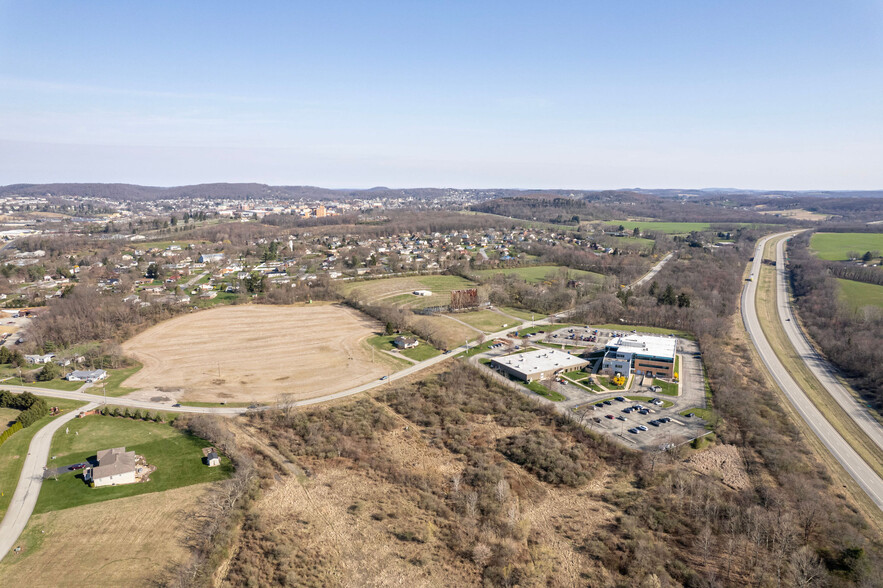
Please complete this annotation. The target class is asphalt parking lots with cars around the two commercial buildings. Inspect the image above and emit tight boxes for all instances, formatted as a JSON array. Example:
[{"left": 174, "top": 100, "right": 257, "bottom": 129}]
[{"left": 481, "top": 326, "right": 706, "bottom": 449}]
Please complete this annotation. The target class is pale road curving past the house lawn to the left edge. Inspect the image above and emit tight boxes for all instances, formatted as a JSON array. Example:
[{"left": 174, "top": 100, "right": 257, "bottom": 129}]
[{"left": 0, "top": 403, "right": 98, "bottom": 560}]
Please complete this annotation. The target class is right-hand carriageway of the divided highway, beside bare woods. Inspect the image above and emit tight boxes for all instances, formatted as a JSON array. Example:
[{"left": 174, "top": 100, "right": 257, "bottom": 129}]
[{"left": 776, "top": 234, "right": 883, "bottom": 449}]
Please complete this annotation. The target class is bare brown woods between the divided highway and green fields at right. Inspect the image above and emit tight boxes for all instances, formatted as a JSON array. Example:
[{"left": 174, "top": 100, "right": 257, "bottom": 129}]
[{"left": 788, "top": 233, "right": 883, "bottom": 411}]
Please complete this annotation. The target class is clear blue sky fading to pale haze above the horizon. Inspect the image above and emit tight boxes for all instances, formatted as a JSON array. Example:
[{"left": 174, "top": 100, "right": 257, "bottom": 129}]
[{"left": 0, "top": 0, "right": 883, "bottom": 190}]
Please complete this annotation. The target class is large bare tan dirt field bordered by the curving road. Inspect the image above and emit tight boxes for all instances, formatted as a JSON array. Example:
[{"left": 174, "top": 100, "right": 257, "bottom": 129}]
[{"left": 123, "top": 304, "right": 395, "bottom": 402}]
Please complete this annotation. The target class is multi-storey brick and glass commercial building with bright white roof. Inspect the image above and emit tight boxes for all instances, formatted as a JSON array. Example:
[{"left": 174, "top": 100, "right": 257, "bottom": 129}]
[{"left": 601, "top": 335, "right": 678, "bottom": 378}]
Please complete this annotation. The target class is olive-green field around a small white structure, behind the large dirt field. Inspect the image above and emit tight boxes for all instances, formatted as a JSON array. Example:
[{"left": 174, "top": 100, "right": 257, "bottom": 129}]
[{"left": 340, "top": 275, "right": 476, "bottom": 308}]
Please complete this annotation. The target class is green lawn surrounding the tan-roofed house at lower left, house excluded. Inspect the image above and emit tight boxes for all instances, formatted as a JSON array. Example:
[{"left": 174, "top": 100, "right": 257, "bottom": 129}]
[{"left": 34, "top": 415, "right": 233, "bottom": 513}]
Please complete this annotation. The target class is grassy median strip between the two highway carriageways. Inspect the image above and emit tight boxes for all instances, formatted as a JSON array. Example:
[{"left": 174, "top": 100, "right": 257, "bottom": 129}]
[{"left": 756, "top": 239, "right": 883, "bottom": 476}]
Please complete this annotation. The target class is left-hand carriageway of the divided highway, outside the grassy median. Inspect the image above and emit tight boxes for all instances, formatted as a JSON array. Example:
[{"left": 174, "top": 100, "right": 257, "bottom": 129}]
[{"left": 742, "top": 232, "right": 883, "bottom": 510}]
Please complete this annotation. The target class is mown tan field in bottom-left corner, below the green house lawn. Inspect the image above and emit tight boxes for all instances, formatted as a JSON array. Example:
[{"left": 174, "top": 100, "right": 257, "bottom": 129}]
[{"left": 0, "top": 484, "right": 210, "bottom": 586}]
